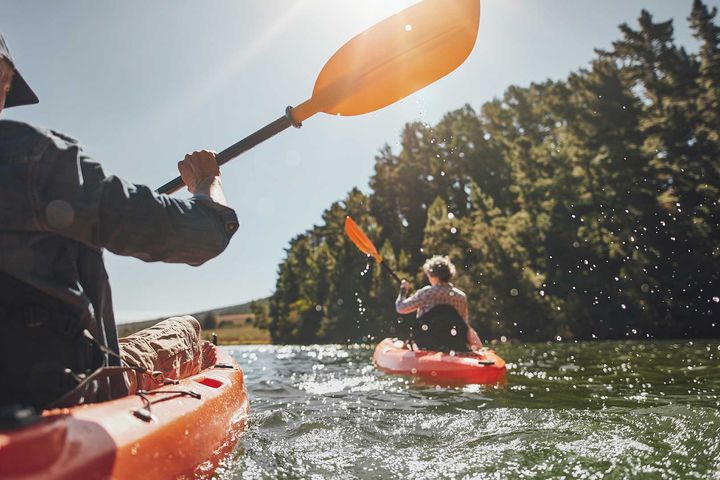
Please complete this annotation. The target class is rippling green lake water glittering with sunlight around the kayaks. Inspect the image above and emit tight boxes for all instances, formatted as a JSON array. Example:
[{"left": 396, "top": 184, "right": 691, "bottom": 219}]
[{"left": 219, "top": 341, "right": 720, "bottom": 479}]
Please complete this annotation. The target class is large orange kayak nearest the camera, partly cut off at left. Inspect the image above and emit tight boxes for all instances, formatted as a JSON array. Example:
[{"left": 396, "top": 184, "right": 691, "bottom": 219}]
[{"left": 0, "top": 350, "right": 249, "bottom": 480}]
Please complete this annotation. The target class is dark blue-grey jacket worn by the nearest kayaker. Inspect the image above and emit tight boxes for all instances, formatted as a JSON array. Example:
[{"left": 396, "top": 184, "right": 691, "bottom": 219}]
[{"left": 0, "top": 120, "right": 238, "bottom": 404}]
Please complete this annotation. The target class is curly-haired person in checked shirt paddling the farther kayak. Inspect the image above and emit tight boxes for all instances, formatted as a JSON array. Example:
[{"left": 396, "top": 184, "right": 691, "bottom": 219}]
[{"left": 395, "top": 255, "right": 482, "bottom": 351}]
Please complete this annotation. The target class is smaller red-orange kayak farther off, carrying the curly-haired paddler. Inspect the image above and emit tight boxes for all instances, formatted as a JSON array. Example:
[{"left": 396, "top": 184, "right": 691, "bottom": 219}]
[{"left": 373, "top": 338, "right": 507, "bottom": 384}]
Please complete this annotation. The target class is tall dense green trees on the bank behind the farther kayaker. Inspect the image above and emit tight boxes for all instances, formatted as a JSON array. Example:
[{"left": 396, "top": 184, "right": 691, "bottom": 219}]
[{"left": 270, "top": 0, "right": 720, "bottom": 343}]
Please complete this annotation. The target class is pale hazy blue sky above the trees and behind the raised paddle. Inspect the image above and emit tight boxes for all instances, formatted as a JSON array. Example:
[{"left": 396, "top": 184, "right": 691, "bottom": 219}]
[{"left": 0, "top": 0, "right": 720, "bottom": 321}]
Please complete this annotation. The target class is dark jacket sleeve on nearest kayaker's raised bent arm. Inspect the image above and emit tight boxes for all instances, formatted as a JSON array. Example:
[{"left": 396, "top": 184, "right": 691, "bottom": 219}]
[{"left": 35, "top": 134, "right": 238, "bottom": 265}]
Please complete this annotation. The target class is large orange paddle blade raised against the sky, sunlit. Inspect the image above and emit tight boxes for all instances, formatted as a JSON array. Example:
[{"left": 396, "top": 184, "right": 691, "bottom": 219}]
[{"left": 292, "top": 0, "right": 480, "bottom": 122}]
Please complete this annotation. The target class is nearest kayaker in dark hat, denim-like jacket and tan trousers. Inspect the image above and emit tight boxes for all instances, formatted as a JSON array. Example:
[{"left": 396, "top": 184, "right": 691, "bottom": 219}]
[{"left": 0, "top": 35, "right": 238, "bottom": 409}]
